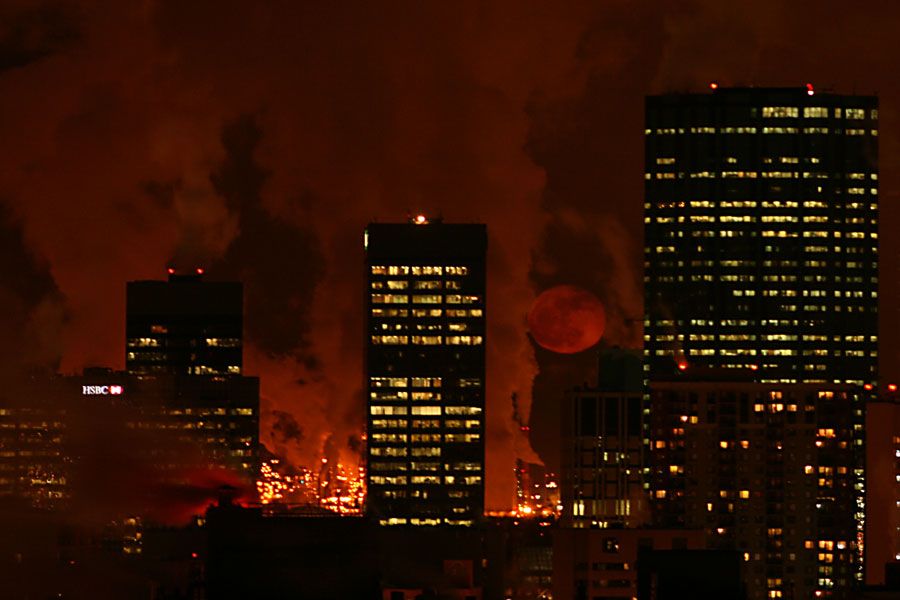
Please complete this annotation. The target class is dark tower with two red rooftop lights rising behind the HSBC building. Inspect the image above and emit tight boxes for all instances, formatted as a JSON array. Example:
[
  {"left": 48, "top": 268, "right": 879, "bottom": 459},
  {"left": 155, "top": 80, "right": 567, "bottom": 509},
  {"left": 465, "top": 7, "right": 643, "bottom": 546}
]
[{"left": 125, "top": 269, "right": 243, "bottom": 375}]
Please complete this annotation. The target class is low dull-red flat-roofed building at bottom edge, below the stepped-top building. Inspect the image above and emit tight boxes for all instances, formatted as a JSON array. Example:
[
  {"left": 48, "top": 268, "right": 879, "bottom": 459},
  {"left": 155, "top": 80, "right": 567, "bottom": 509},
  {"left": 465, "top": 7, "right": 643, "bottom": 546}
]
[{"left": 553, "top": 527, "right": 706, "bottom": 600}]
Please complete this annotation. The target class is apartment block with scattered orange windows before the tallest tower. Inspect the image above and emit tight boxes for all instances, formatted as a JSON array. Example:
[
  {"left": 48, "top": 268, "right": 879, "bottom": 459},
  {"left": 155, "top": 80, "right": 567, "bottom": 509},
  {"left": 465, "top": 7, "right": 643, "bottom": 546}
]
[{"left": 650, "top": 378, "right": 865, "bottom": 600}]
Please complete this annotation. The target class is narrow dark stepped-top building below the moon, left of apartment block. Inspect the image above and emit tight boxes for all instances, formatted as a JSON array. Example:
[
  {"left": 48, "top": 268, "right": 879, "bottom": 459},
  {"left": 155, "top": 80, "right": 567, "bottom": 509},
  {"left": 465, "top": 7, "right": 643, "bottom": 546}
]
[{"left": 560, "top": 349, "right": 650, "bottom": 528}]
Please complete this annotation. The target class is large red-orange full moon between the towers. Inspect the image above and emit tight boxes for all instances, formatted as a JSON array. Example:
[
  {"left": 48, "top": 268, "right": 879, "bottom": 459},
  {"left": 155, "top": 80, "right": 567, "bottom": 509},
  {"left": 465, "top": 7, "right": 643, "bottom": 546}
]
[{"left": 528, "top": 285, "right": 606, "bottom": 354}]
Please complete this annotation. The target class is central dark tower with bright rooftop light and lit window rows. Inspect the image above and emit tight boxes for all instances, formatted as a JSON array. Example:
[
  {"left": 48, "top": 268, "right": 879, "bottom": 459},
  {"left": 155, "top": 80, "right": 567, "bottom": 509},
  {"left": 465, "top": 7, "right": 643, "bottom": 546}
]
[{"left": 365, "top": 216, "right": 487, "bottom": 525}]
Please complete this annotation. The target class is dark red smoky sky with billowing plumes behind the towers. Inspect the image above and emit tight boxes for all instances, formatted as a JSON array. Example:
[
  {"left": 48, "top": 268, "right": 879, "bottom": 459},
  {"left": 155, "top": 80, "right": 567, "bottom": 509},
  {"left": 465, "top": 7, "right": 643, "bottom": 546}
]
[{"left": 0, "top": 0, "right": 900, "bottom": 508}]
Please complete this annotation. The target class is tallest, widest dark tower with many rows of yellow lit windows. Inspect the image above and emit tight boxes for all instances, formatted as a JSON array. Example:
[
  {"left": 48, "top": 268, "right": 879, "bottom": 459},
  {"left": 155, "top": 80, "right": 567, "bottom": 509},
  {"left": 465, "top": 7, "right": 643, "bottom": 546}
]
[{"left": 644, "top": 86, "right": 878, "bottom": 384}]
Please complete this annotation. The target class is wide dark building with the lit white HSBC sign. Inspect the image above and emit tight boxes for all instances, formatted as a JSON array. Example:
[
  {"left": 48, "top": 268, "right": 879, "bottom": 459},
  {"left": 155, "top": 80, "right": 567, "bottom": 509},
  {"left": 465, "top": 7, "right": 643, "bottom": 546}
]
[{"left": 0, "top": 369, "right": 259, "bottom": 508}]
